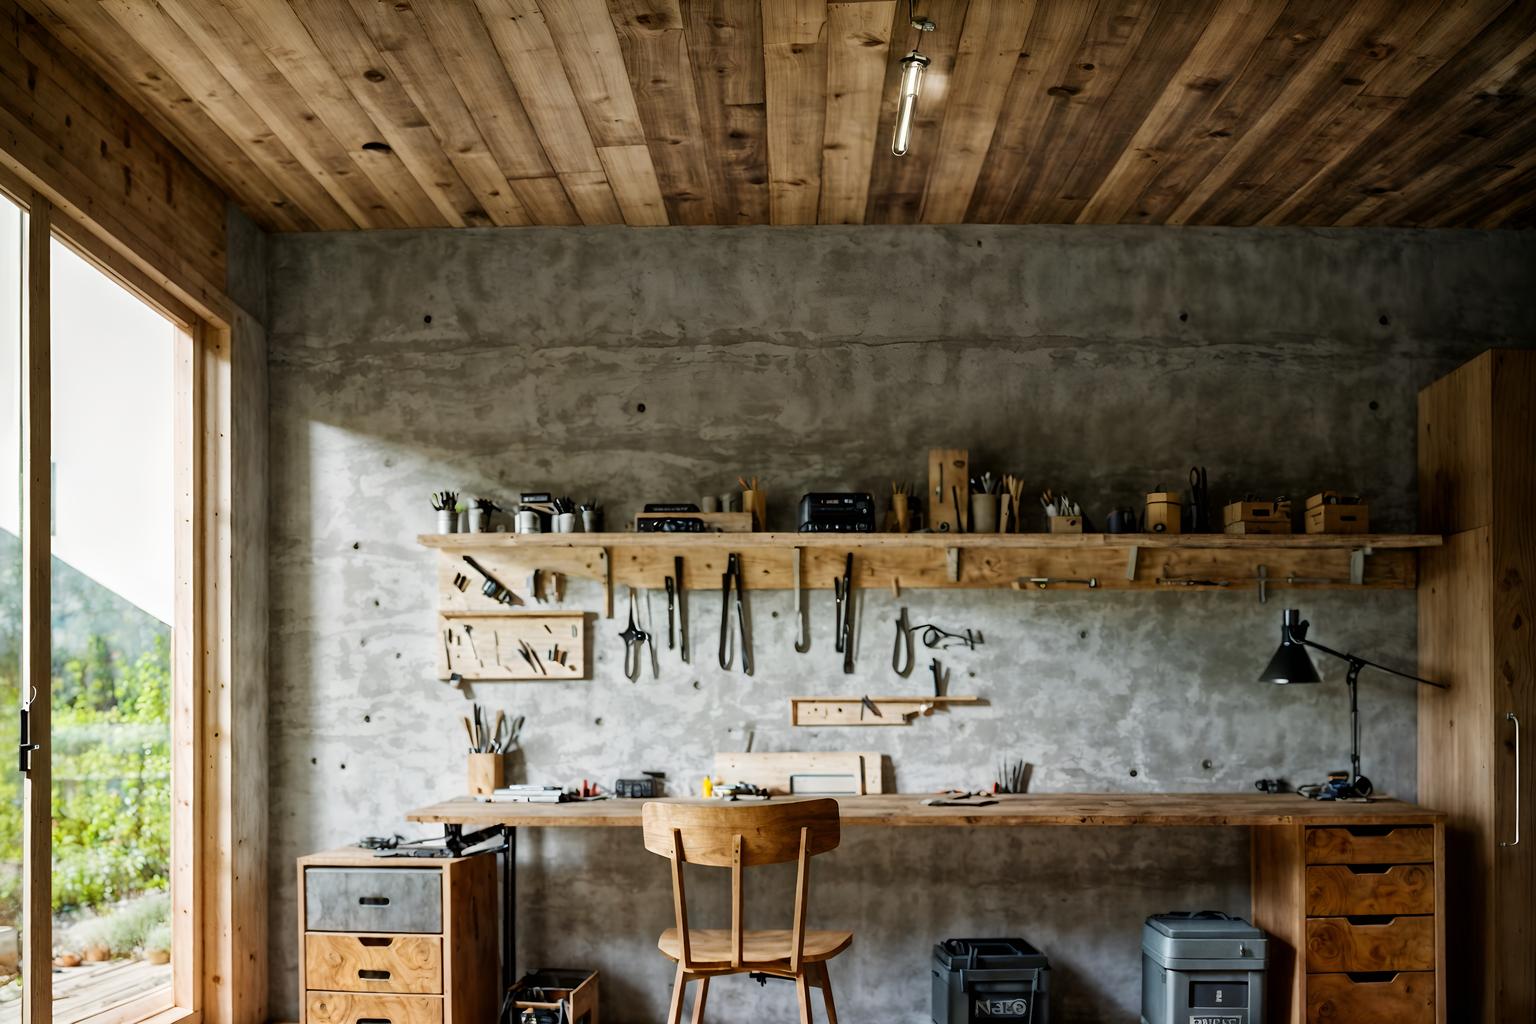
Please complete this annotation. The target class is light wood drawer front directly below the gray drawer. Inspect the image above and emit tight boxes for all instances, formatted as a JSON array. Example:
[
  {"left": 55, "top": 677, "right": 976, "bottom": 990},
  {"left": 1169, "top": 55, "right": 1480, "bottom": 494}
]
[{"left": 304, "top": 932, "right": 442, "bottom": 995}]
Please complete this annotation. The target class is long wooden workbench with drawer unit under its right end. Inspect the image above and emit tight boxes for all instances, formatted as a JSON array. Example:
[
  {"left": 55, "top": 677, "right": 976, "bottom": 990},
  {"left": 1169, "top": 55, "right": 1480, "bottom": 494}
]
[{"left": 406, "top": 792, "right": 1445, "bottom": 1024}]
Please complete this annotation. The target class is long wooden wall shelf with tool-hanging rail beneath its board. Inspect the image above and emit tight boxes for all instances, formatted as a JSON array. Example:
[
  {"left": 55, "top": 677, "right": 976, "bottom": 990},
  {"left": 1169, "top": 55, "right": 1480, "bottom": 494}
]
[{"left": 419, "top": 533, "right": 1441, "bottom": 617}]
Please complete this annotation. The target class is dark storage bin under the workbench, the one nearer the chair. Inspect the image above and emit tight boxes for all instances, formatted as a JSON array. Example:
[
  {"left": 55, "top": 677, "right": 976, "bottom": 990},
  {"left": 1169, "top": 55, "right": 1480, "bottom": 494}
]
[{"left": 932, "top": 938, "right": 1051, "bottom": 1024}]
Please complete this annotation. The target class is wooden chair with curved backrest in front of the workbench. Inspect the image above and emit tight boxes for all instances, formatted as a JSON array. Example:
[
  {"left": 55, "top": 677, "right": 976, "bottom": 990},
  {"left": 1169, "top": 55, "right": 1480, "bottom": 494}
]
[{"left": 645, "top": 800, "right": 854, "bottom": 1024}]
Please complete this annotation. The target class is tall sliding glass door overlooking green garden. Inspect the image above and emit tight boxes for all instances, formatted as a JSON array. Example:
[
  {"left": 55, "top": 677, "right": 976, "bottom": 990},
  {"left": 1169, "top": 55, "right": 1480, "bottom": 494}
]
[{"left": 0, "top": 188, "right": 187, "bottom": 1024}]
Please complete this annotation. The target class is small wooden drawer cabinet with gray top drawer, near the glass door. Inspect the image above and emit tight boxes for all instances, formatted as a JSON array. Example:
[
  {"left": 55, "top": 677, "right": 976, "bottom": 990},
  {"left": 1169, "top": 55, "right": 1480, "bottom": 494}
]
[{"left": 298, "top": 849, "right": 501, "bottom": 1024}]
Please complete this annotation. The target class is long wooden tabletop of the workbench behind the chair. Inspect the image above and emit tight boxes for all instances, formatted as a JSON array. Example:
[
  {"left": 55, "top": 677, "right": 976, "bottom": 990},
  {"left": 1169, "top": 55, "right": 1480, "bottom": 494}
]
[{"left": 406, "top": 792, "right": 1445, "bottom": 829}]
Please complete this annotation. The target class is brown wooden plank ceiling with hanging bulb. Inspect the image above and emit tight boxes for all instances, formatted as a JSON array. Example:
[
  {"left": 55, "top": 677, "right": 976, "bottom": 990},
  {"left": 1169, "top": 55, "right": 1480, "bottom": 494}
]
[{"left": 22, "top": 0, "right": 1536, "bottom": 230}]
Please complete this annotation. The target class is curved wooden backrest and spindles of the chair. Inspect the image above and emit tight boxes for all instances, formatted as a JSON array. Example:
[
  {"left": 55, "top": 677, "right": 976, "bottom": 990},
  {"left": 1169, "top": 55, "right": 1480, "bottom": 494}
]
[{"left": 644, "top": 798, "right": 842, "bottom": 970}]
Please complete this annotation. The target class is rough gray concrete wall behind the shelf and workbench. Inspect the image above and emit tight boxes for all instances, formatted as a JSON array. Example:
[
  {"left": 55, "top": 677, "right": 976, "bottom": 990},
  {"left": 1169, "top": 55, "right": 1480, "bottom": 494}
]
[{"left": 269, "top": 227, "right": 1536, "bottom": 1022}]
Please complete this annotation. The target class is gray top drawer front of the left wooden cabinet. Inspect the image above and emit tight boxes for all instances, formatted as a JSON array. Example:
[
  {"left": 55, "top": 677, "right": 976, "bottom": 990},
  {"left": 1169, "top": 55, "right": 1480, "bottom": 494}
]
[{"left": 304, "top": 867, "right": 442, "bottom": 933}]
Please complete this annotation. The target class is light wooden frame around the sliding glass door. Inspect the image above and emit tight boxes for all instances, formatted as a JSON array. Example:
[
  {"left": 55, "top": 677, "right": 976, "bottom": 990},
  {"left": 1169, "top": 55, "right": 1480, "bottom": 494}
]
[{"left": 0, "top": 174, "right": 233, "bottom": 1024}]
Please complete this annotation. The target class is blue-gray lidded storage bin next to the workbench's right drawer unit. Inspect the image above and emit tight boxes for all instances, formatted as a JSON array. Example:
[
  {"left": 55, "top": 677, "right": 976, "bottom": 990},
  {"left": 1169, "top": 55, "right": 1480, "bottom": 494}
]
[{"left": 1141, "top": 910, "right": 1269, "bottom": 1024}]
